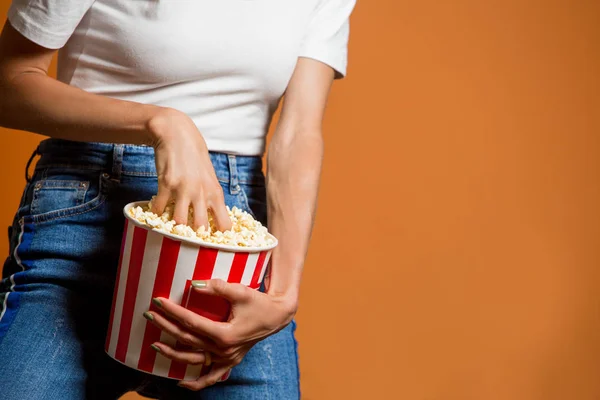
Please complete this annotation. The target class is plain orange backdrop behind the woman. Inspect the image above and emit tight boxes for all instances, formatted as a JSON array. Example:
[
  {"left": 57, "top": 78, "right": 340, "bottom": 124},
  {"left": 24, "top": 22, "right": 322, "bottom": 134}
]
[{"left": 0, "top": 0, "right": 600, "bottom": 400}]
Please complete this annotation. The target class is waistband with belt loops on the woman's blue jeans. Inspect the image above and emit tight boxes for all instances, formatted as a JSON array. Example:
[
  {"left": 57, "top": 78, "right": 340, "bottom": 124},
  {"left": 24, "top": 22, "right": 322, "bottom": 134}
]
[{"left": 34, "top": 139, "right": 264, "bottom": 186}]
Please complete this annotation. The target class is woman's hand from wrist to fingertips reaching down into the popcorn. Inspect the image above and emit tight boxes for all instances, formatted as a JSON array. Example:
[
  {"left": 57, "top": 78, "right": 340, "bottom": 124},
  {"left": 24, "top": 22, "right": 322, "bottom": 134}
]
[{"left": 148, "top": 108, "right": 231, "bottom": 231}]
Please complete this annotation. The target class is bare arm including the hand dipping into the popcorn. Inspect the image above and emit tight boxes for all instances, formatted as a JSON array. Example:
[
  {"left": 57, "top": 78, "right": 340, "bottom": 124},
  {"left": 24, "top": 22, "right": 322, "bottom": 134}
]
[{"left": 0, "top": 23, "right": 231, "bottom": 230}]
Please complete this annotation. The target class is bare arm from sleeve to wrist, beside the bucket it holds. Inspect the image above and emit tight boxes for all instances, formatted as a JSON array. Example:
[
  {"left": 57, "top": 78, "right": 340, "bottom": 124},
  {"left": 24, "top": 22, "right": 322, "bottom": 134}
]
[{"left": 267, "top": 58, "right": 334, "bottom": 310}]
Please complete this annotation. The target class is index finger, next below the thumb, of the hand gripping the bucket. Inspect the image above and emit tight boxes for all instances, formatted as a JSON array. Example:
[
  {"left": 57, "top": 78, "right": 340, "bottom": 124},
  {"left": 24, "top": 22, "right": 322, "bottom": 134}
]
[{"left": 153, "top": 298, "right": 230, "bottom": 344}]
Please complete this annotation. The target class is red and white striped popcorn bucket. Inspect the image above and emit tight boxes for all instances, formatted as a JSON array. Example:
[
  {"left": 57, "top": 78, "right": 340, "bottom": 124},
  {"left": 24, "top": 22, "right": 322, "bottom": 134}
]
[{"left": 105, "top": 202, "right": 277, "bottom": 380}]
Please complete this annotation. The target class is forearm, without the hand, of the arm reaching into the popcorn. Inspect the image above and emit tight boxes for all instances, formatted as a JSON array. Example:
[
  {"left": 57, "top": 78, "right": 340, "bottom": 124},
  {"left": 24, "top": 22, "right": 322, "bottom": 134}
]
[{"left": 0, "top": 72, "right": 159, "bottom": 144}]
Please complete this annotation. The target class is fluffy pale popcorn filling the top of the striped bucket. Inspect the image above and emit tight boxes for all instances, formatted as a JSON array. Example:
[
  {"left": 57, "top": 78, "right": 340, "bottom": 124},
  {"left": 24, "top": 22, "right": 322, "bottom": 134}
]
[{"left": 129, "top": 198, "right": 275, "bottom": 247}]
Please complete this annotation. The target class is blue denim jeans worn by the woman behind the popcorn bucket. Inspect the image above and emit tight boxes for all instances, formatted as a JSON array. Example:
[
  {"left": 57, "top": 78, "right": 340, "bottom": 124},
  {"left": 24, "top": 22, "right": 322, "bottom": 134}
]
[{"left": 0, "top": 139, "right": 299, "bottom": 400}]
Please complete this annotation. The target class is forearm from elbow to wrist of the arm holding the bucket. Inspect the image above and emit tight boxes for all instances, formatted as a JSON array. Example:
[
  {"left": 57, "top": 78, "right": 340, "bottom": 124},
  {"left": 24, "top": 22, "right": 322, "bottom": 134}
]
[{"left": 267, "top": 130, "right": 323, "bottom": 305}]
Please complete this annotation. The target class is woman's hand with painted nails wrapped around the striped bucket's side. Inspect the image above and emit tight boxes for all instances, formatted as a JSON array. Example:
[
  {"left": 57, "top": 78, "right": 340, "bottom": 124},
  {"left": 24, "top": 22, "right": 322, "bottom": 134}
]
[{"left": 146, "top": 279, "right": 296, "bottom": 390}]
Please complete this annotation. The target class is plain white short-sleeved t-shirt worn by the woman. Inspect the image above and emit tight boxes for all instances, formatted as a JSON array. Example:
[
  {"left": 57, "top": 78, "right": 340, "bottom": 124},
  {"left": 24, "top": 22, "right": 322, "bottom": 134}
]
[{"left": 8, "top": 0, "right": 355, "bottom": 155}]
